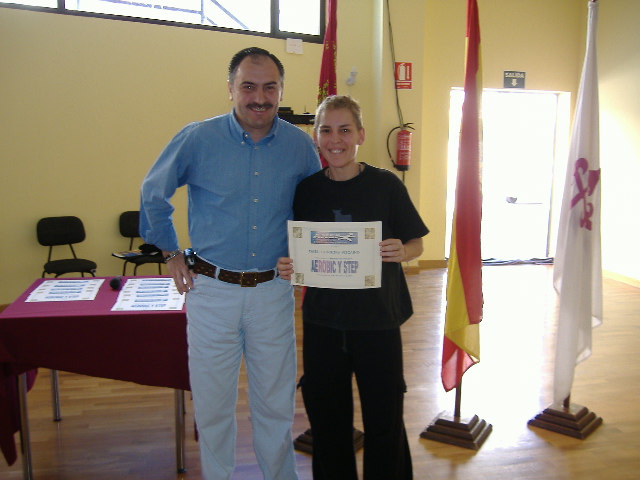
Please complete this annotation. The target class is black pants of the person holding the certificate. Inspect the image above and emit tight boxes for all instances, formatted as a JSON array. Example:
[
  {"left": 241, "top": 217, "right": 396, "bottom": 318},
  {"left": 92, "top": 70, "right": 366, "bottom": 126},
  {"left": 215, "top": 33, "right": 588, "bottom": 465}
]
[{"left": 300, "top": 322, "right": 413, "bottom": 480}]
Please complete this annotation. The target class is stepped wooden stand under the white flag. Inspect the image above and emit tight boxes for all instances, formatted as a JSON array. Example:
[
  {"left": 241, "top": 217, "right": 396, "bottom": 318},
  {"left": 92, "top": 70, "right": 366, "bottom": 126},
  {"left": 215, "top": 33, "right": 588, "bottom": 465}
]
[{"left": 528, "top": 395, "right": 602, "bottom": 440}]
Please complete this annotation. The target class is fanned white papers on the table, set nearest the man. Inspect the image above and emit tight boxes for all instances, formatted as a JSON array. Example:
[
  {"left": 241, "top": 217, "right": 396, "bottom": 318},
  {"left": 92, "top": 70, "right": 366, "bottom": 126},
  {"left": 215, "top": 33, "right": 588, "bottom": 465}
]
[{"left": 111, "top": 277, "right": 184, "bottom": 312}]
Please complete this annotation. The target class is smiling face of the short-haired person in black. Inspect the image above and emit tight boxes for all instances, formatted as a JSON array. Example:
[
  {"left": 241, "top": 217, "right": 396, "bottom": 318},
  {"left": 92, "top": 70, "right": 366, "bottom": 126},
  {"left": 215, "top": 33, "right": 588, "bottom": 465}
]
[{"left": 313, "top": 108, "right": 364, "bottom": 168}]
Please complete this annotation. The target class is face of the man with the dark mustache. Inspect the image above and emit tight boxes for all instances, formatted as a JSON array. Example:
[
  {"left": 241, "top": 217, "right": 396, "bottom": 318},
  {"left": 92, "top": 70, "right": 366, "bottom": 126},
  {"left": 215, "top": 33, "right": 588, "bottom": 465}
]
[{"left": 229, "top": 56, "right": 283, "bottom": 141}]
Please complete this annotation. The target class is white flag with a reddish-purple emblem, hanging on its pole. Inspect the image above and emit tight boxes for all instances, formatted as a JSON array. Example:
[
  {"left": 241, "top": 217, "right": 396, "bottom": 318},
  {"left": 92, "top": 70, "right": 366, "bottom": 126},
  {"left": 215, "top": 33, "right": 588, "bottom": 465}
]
[{"left": 553, "top": 0, "right": 602, "bottom": 403}]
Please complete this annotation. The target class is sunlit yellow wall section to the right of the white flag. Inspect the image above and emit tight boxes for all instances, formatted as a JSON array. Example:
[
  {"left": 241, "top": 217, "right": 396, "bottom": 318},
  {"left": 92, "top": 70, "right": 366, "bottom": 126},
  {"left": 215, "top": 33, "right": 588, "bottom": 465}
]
[{"left": 598, "top": 0, "right": 640, "bottom": 286}]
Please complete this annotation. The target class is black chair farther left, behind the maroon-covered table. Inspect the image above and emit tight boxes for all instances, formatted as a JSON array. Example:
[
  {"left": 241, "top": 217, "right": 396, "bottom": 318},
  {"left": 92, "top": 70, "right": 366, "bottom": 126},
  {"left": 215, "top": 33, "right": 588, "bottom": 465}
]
[{"left": 36, "top": 216, "right": 97, "bottom": 278}]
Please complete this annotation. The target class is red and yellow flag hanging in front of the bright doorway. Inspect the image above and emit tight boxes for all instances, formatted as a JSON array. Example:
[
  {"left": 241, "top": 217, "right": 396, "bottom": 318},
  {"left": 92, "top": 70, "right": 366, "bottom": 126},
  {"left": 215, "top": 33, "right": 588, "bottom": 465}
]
[{"left": 442, "top": 0, "right": 483, "bottom": 391}]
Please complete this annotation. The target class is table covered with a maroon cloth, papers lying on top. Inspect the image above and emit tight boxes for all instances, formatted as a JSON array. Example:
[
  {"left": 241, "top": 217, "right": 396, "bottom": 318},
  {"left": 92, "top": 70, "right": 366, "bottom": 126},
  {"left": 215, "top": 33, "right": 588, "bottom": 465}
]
[{"left": 0, "top": 275, "right": 190, "bottom": 479}]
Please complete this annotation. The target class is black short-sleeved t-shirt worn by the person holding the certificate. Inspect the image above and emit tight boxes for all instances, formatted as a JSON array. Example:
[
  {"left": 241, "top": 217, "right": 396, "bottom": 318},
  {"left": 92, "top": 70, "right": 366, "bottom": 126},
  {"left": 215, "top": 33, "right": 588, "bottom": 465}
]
[{"left": 293, "top": 164, "right": 429, "bottom": 330}]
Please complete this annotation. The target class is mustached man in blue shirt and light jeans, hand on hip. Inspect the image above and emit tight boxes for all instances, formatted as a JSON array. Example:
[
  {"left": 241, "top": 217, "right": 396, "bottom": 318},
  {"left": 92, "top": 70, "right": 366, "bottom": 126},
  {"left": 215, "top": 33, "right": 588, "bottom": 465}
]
[{"left": 140, "top": 47, "right": 320, "bottom": 480}]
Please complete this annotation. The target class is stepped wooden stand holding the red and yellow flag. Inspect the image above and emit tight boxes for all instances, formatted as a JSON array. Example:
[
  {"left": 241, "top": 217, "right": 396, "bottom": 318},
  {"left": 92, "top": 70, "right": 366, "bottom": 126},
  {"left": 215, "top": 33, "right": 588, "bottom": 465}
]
[{"left": 420, "top": 382, "right": 493, "bottom": 450}]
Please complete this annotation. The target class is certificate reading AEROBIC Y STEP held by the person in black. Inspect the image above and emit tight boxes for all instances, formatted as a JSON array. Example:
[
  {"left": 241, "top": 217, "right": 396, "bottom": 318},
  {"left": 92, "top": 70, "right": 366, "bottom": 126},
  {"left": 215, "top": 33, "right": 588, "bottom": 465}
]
[{"left": 288, "top": 220, "right": 382, "bottom": 288}]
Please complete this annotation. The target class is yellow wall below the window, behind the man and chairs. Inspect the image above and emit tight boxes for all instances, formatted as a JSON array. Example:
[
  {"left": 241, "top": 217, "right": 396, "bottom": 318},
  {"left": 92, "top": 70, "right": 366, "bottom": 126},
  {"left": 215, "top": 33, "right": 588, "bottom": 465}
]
[{"left": 0, "top": 8, "right": 321, "bottom": 304}]
